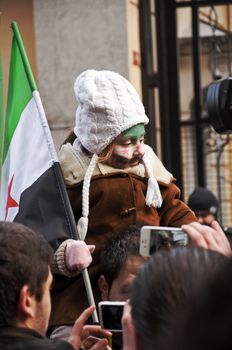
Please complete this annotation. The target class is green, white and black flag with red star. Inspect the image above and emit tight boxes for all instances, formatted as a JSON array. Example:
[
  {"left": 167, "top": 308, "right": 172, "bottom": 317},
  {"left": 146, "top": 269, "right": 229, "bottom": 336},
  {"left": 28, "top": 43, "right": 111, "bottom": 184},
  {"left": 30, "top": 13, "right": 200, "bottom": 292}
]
[{"left": 0, "top": 22, "right": 76, "bottom": 247}]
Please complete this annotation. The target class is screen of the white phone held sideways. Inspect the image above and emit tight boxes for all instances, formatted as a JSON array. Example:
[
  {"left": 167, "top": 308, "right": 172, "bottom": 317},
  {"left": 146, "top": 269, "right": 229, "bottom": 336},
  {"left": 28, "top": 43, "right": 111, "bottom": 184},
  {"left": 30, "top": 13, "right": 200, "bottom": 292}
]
[{"left": 150, "top": 229, "right": 188, "bottom": 255}]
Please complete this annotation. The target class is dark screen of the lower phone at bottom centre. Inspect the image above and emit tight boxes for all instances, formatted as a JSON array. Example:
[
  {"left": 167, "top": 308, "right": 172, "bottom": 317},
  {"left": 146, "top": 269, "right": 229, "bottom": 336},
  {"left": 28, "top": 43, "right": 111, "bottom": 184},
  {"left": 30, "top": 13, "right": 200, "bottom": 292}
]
[{"left": 101, "top": 305, "right": 123, "bottom": 331}]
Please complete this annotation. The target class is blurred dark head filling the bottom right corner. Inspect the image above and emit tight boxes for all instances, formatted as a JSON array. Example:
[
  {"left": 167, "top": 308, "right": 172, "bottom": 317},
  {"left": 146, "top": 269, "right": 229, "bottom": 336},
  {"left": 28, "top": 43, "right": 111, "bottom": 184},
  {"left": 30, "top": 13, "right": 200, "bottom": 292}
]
[{"left": 162, "top": 259, "right": 232, "bottom": 350}]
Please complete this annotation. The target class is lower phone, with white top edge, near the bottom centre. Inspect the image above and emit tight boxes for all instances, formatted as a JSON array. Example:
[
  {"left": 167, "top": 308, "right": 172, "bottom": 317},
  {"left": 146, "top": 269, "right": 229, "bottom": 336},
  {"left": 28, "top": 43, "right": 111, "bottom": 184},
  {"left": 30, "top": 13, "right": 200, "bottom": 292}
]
[{"left": 98, "top": 301, "right": 125, "bottom": 332}]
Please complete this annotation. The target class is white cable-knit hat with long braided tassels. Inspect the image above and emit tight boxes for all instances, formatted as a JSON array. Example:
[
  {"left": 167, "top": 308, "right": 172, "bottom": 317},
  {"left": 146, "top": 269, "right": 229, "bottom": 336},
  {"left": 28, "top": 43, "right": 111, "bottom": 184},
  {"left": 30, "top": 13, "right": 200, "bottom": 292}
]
[{"left": 73, "top": 70, "right": 162, "bottom": 239}]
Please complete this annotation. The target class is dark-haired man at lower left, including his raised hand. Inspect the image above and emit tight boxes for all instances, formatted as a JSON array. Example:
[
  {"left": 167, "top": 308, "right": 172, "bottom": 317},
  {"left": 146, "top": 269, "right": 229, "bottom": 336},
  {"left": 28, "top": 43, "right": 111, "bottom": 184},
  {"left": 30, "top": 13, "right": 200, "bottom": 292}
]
[{"left": 0, "top": 222, "right": 111, "bottom": 350}]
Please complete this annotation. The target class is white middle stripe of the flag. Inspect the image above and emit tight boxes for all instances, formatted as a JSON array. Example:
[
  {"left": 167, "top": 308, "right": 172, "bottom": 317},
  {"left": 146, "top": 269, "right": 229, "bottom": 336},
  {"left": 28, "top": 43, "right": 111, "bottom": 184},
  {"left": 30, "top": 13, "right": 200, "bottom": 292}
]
[{"left": 0, "top": 98, "right": 52, "bottom": 221}]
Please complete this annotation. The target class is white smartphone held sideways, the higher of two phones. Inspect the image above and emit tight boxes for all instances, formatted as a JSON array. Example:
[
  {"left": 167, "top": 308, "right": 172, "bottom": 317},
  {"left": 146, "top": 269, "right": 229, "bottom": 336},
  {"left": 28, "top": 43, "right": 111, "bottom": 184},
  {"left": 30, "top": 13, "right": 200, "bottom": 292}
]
[{"left": 139, "top": 226, "right": 188, "bottom": 256}]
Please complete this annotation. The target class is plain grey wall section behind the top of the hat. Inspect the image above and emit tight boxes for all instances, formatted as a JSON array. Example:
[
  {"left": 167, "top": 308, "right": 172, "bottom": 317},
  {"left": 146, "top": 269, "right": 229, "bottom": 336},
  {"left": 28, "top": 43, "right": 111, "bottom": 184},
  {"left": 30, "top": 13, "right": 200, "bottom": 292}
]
[{"left": 34, "top": 0, "right": 129, "bottom": 145}]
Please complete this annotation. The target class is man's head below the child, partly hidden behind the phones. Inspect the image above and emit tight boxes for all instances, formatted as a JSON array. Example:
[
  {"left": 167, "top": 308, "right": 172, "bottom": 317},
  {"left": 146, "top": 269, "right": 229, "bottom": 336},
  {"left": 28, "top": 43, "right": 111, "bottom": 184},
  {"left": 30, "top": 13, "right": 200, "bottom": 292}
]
[{"left": 98, "top": 224, "right": 145, "bottom": 301}]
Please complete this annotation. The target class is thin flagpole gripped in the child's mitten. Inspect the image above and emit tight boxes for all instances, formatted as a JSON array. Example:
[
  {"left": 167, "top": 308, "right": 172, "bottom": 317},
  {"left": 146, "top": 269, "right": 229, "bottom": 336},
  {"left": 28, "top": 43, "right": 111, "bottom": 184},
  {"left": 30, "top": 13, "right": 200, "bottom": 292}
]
[{"left": 11, "top": 22, "right": 99, "bottom": 323}]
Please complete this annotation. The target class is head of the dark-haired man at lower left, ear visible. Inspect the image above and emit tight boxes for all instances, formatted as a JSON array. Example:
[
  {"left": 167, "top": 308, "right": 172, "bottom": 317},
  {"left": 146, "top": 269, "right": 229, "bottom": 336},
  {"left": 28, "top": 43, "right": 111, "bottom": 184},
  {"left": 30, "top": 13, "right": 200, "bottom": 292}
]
[{"left": 0, "top": 222, "right": 52, "bottom": 335}]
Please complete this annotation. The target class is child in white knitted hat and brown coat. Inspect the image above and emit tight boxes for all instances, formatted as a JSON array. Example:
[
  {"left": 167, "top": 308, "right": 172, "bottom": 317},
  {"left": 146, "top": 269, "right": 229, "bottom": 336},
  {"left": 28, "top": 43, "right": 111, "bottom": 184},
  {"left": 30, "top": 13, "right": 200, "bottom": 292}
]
[{"left": 50, "top": 70, "right": 197, "bottom": 336}]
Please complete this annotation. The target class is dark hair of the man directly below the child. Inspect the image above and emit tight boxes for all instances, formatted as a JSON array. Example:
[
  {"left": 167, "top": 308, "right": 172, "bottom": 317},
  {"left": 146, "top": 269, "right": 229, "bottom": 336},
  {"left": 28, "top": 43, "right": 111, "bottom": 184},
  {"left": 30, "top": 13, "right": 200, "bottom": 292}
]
[{"left": 100, "top": 223, "right": 143, "bottom": 288}]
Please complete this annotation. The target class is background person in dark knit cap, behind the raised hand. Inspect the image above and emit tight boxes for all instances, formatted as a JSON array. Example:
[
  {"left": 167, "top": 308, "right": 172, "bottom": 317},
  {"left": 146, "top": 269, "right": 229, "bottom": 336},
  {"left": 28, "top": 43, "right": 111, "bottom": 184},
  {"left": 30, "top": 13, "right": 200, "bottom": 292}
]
[{"left": 188, "top": 187, "right": 219, "bottom": 225}]
